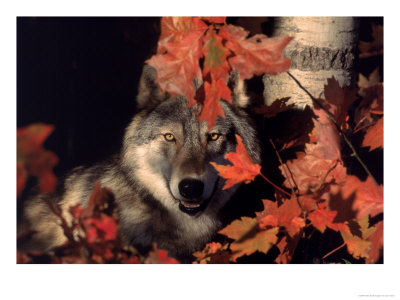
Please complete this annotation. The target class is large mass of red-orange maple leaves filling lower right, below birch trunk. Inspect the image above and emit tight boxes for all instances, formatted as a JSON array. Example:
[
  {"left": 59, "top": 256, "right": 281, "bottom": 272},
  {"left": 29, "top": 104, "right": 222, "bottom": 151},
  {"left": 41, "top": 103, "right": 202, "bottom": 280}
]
[{"left": 194, "top": 21, "right": 383, "bottom": 263}]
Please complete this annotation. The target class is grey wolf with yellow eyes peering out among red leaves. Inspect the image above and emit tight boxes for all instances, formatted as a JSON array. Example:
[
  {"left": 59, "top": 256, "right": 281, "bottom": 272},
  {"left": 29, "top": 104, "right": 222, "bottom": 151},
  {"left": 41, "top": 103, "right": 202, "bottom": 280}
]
[{"left": 19, "top": 66, "right": 260, "bottom": 261}]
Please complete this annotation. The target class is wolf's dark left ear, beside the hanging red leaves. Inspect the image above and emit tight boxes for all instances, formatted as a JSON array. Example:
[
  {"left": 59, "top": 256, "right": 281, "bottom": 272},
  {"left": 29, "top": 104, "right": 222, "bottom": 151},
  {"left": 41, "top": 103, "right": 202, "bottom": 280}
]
[{"left": 136, "top": 65, "right": 168, "bottom": 109}]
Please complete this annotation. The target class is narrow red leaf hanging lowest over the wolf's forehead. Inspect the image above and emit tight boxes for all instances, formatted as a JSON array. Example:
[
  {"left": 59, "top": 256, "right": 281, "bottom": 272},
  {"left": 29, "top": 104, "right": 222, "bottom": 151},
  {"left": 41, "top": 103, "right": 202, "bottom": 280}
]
[{"left": 199, "top": 78, "right": 232, "bottom": 130}]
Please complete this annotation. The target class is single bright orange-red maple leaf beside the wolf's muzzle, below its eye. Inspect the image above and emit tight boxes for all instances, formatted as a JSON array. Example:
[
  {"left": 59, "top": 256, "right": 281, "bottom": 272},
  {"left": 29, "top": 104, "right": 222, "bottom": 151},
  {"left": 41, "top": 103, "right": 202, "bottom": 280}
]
[{"left": 210, "top": 135, "right": 261, "bottom": 190}]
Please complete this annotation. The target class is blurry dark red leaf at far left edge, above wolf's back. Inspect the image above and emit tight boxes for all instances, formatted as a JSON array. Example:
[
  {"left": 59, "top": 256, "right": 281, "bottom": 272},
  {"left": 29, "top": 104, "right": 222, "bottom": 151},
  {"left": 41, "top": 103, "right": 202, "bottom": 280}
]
[{"left": 17, "top": 123, "right": 58, "bottom": 196}]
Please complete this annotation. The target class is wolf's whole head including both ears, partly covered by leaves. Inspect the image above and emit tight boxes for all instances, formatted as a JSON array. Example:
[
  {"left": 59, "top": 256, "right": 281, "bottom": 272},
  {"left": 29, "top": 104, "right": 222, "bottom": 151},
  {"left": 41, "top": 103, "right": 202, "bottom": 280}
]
[{"left": 121, "top": 66, "right": 260, "bottom": 216}]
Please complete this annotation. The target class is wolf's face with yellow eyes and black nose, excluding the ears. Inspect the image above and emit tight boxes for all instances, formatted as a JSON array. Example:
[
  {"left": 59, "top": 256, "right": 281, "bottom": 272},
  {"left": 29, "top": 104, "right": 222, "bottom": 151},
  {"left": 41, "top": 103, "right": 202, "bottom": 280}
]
[{"left": 123, "top": 97, "right": 235, "bottom": 215}]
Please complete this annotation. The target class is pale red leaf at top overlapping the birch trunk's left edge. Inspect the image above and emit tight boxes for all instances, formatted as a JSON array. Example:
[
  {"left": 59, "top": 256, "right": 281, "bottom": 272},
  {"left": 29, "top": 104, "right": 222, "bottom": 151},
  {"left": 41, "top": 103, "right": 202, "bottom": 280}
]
[{"left": 219, "top": 25, "right": 292, "bottom": 79}]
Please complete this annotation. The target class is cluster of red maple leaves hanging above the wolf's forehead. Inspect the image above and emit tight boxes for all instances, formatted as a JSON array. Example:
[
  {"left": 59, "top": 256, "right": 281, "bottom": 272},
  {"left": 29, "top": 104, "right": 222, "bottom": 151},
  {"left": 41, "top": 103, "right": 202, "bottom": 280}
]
[{"left": 147, "top": 17, "right": 291, "bottom": 128}]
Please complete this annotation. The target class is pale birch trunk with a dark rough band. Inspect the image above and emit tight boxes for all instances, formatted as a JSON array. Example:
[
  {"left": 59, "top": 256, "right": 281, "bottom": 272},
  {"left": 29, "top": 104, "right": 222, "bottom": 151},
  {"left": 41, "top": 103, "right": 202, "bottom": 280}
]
[{"left": 263, "top": 17, "right": 359, "bottom": 107}]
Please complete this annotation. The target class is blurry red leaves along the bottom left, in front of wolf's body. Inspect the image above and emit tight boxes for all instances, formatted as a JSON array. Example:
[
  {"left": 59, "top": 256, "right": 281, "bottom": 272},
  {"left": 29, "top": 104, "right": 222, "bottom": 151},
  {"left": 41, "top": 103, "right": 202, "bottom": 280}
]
[{"left": 17, "top": 183, "right": 178, "bottom": 264}]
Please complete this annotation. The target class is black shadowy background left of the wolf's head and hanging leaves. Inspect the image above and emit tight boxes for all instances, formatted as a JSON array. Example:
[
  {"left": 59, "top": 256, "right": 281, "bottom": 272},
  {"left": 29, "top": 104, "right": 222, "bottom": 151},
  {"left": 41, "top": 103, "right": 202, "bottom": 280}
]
[{"left": 17, "top": 17, "right": 160, "bottom": 175}]
